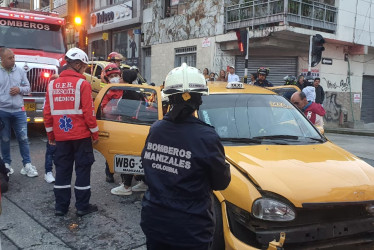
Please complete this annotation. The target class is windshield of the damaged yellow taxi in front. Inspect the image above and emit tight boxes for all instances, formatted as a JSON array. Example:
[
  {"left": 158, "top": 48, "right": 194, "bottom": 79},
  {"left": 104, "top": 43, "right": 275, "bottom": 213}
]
[{"left": 198, "top": 94, "right": 325, "bottom": 144}]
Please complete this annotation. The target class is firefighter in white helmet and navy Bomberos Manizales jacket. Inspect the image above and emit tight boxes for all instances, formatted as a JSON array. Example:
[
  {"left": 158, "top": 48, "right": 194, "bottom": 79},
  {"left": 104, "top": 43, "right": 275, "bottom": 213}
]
[{"left": 140, "top": 63, "right": 231, "bottom": 250}]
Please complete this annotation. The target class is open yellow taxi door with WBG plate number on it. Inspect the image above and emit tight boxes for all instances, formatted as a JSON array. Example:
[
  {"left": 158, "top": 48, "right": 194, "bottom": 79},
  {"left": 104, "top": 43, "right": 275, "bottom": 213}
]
[{"left": 94, "top": 84, "right": 162, "bottom": 174}]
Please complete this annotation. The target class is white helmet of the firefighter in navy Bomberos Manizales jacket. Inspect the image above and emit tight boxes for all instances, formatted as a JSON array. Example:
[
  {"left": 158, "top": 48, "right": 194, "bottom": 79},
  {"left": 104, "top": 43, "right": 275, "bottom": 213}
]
[{"left": 162, "top": 63, "right": 209, "bottom": 97}]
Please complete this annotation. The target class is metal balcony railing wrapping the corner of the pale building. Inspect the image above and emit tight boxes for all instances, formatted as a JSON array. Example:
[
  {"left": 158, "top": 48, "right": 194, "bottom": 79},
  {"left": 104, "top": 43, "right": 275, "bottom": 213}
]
[{"left": 225, "top": 0, "right": 337, "bottom": 33}]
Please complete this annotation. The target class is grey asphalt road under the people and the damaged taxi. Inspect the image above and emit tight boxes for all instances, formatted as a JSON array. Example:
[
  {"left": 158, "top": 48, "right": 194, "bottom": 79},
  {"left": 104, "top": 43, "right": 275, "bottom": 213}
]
[{"left": 0, "top": 127, "right": 374, "bottom": 250}]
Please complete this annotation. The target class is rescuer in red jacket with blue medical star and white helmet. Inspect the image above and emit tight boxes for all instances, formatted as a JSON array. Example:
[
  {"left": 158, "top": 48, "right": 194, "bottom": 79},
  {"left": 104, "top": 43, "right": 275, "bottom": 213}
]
[{"left": 44, "top": 48, "right": 99, "bottom": 216}]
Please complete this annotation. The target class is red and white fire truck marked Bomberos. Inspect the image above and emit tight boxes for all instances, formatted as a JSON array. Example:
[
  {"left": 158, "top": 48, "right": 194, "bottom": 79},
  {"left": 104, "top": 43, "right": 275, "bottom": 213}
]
[{"left": 0, "top": 8, "right": 66, "bottom": 123}]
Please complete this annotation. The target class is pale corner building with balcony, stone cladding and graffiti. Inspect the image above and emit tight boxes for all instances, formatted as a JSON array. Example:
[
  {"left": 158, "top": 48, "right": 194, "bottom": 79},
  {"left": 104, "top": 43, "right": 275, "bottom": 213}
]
[{"left": 142, "top": 0, "right": 374, "bottom": 126}]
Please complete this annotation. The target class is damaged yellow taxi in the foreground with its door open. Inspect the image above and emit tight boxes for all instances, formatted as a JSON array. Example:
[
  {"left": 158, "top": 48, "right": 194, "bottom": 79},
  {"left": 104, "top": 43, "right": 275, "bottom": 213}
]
[{"left": 95, "top": 82, "right": 374, "bottom": 250}]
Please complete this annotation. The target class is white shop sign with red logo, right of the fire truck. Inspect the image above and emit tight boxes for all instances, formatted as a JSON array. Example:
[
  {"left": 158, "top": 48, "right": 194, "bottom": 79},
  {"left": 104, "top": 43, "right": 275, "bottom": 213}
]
[{"left": 91, "top": 1, "right": 132, "bottom": 28}]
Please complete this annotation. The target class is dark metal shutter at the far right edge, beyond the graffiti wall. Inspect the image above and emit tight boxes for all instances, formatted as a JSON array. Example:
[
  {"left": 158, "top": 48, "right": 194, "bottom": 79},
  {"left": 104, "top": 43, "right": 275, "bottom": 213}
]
[{"left": 361, "top": 76, "right": 374, "bottom": 123}]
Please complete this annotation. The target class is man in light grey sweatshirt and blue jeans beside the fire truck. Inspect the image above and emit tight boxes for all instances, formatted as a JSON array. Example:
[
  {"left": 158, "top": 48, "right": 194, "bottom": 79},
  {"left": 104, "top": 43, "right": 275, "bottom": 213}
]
[{"left": 0, "top": 47, "right": 38, "bottom": 177}]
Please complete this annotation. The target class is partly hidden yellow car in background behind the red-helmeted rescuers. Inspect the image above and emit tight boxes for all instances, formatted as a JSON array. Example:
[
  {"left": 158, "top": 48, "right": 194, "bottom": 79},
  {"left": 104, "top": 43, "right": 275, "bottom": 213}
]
[{"left": 83, "top": 61, "right": 146, "bottom": 99}]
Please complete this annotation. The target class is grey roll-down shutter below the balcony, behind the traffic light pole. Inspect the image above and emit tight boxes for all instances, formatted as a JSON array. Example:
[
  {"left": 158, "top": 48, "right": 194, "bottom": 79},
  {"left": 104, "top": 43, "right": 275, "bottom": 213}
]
[{"left": 235, "top": 56, "right": 297, "bottom": 85}]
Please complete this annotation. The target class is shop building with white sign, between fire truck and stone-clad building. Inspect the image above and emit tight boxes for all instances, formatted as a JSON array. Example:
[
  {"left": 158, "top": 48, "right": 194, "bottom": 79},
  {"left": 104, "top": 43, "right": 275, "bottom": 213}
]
[{"left": 80, "top": 0, "right": 141, "bottom": 73}]
